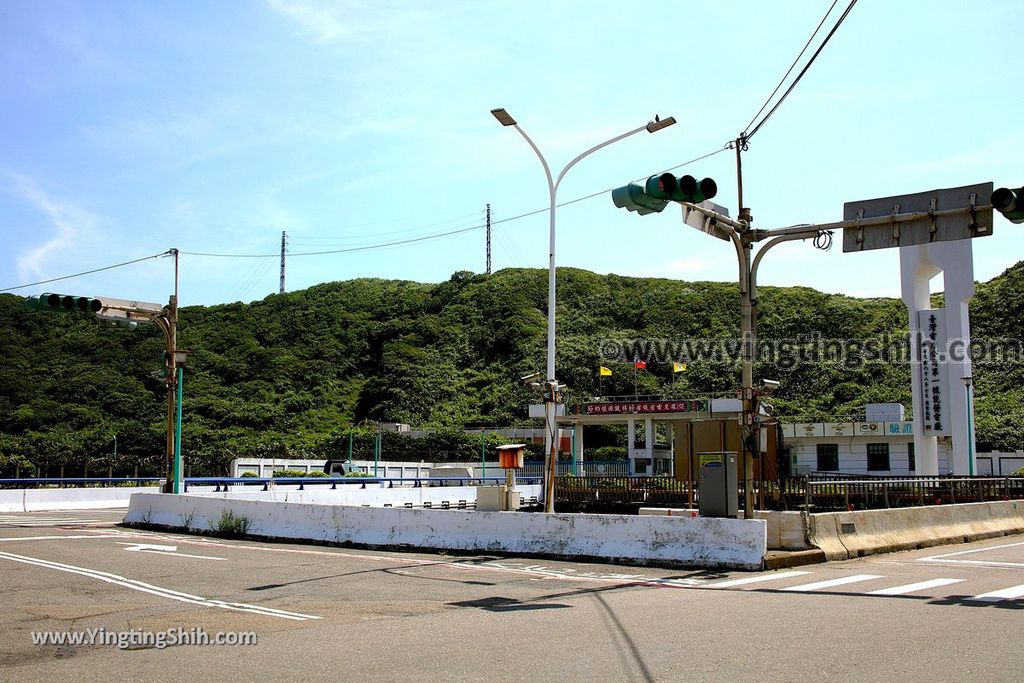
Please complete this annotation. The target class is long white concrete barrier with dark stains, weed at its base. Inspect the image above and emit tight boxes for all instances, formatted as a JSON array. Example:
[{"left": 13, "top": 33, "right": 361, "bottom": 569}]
[{"left": 125, "top": 492, "right": 767, "bottom": 569}]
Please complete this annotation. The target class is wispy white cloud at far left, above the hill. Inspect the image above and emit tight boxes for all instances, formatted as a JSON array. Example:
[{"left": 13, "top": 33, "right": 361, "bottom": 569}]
[{"left": 6, "top": 176, "right": 96, "bottom": 280}]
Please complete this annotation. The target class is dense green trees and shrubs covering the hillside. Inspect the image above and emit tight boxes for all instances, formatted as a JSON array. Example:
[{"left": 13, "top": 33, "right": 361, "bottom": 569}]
[{"left": 0, "top": 264, "right": 1024, "bottom": 474}]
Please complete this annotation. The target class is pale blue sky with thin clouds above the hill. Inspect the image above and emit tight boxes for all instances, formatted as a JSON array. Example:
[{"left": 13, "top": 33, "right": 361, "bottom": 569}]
[{"left": 0, "top": 0, "right": 1024, "bottom": 304}]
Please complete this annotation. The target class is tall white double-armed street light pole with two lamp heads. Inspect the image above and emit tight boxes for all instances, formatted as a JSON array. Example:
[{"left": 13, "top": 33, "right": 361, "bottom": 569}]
[{"left": 490, "top": 109, "right": 676, "bottom": 512}]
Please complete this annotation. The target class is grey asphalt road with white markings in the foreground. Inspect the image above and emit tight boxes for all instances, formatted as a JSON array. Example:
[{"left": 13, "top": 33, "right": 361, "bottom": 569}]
[{"left": 0, "top": 511, "right": 1024, "bottom": 682}]
